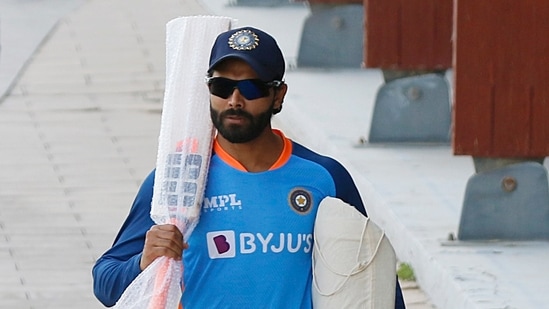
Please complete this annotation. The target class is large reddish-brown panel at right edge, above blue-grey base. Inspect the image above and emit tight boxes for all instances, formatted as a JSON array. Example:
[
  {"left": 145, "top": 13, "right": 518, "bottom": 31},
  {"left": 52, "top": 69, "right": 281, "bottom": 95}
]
[{"left": 453, "top": 0, "right": 549, "bottom": 157}]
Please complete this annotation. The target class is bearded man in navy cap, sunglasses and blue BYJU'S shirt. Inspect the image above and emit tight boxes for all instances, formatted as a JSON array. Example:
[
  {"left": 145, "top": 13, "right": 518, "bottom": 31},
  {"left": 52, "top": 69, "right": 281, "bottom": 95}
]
[{"left": 93, "top": 27, "right": 404, "bottom": 309}]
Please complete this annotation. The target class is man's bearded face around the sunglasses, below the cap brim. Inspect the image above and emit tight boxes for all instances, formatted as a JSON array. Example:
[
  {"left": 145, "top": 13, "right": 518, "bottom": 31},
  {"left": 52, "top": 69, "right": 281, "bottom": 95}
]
[{"left": 210, "top": 59, "right": 278, "bottom": 143}]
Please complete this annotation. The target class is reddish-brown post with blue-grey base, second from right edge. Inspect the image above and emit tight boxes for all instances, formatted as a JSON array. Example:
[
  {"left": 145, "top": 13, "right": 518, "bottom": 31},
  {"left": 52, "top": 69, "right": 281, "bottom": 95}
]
[{"left": 364, "top": 0, "right": 452, "bottom": 143}]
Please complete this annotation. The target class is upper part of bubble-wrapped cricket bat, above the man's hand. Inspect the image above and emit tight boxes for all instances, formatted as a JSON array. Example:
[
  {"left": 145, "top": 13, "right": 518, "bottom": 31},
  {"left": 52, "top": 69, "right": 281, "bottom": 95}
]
[{"left": 151, "top": 16, "right": 231, "bottom": 238}]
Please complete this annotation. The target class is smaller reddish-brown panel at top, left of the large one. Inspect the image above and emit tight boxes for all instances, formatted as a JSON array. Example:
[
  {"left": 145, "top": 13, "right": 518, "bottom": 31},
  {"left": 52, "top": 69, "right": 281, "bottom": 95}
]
[{"left": 364, "top": 0, "right": 453, "bottom": 70}]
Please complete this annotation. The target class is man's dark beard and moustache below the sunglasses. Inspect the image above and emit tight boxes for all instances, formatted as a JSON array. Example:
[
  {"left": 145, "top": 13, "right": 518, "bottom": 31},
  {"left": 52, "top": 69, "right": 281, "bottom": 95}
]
[{"left": 210, "top": 102, "right": 274, "bottom": 144}]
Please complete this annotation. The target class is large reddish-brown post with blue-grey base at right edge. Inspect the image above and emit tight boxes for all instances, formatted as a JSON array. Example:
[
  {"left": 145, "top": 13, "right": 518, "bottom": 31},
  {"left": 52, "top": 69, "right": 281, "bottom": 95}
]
[{"left": 453, "top": 0, "right": 549, "bottom": 240}]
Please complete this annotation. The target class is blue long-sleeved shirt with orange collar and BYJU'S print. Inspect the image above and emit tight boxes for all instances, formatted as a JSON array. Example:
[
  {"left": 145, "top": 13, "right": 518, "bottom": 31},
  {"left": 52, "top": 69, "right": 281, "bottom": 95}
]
[{"left": 93, "top": 131, "right": 404, "bottom": 309}]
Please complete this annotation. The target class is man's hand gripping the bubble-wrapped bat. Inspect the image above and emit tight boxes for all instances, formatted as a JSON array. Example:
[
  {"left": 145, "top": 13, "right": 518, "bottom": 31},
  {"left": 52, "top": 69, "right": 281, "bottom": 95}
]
[{"left": 139, "top": 224, "right": 189, "bottom": 270}]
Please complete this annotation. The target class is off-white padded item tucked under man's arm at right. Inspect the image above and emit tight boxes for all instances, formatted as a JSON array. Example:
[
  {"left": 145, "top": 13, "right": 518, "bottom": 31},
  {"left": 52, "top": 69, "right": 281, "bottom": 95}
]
[{"left": 312, "top": 197, "right": 396, "bottom": 309}]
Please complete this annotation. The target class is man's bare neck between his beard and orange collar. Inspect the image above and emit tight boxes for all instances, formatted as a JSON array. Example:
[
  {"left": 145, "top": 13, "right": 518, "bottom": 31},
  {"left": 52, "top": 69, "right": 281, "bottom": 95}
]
[{"left": 216, "top": 128, "right": 284, "bottom": 172}]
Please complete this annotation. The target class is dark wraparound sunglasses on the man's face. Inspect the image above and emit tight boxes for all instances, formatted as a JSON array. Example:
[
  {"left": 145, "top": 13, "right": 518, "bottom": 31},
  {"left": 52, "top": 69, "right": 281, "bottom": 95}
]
[{"left": 206, "top": 77, "right": 283, "bottom": 100}]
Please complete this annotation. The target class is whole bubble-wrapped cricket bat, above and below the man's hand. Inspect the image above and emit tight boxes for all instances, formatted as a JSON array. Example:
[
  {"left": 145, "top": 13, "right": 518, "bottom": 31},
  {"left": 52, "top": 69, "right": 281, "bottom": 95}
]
[{"left": 114, "top": 16, "right": 234, "bottom": 309}]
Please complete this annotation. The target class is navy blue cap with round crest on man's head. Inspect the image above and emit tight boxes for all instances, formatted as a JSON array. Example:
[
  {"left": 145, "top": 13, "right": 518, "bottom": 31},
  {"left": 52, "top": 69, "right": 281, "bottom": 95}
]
[{"left": 208, "top": 27, "right": 285, "bottom": 82}]
